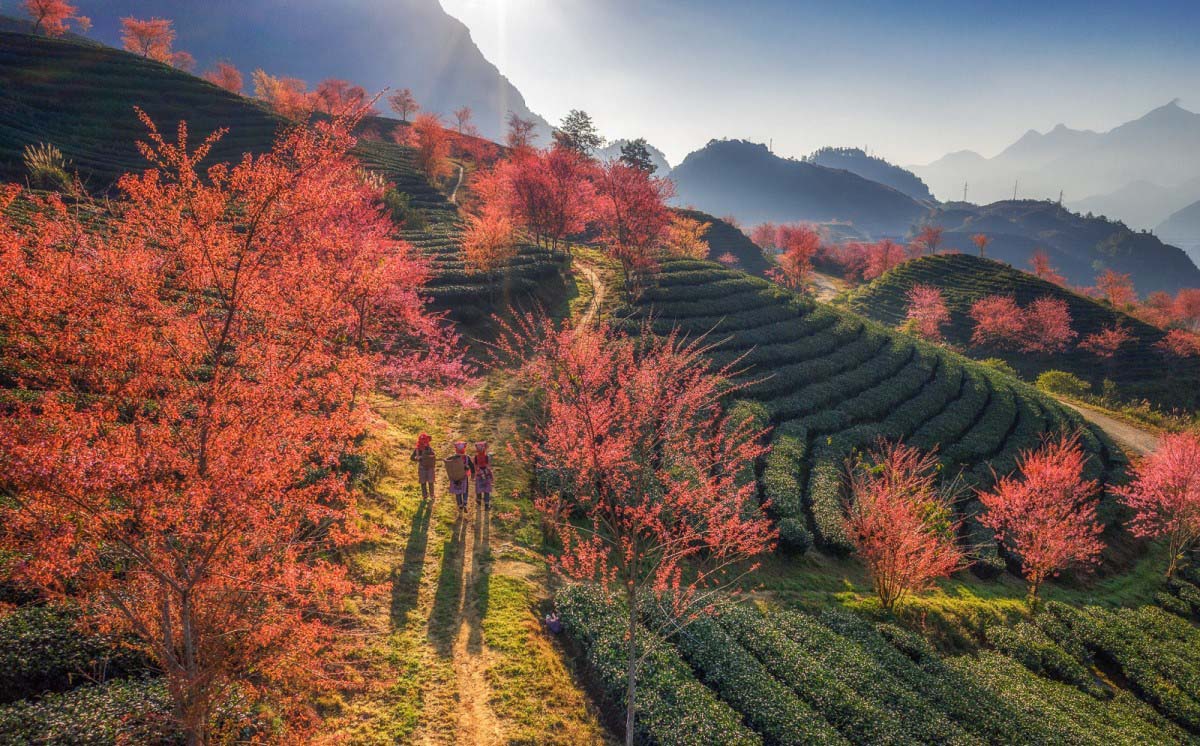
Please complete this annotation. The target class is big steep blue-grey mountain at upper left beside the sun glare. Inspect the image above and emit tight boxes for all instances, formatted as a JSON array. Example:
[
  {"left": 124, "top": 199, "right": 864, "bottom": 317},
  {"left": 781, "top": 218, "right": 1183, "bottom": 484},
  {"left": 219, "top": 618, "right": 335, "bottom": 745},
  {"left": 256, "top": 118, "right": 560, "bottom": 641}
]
[{"left": 68, "top": 0, "right": 550, "bottom": 144}]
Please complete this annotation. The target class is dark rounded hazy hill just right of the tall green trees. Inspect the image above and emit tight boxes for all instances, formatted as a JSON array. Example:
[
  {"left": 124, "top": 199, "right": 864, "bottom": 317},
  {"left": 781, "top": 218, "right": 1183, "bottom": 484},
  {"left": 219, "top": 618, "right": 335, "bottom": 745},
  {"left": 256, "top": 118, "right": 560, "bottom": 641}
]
[{"left": 671, "top": 140, "right": 928, "bottom": 236}]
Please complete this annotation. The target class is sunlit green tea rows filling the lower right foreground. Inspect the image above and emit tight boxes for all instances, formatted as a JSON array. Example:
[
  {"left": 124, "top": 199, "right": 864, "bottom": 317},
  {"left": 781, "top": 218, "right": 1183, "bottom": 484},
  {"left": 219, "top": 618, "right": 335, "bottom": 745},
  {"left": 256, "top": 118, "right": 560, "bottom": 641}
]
[{"left": 557, "top": 586, "right": 1200, "bottom": 746}]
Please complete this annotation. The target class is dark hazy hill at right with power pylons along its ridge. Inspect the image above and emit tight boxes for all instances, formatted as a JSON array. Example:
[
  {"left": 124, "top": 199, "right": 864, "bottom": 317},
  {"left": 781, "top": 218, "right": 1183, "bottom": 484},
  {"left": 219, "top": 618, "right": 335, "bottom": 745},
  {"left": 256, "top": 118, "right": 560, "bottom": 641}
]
[{"left": 930, "top": 199, "right": 1200, "bottom": 294}]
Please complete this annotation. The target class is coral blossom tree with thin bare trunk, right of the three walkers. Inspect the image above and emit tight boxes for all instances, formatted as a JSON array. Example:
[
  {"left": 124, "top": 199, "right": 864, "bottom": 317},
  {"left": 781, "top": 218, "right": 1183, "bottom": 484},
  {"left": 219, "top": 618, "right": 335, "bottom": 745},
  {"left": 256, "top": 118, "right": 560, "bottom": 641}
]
[{"left": 505, "top": 316, "right": 775, "bottom": 744}]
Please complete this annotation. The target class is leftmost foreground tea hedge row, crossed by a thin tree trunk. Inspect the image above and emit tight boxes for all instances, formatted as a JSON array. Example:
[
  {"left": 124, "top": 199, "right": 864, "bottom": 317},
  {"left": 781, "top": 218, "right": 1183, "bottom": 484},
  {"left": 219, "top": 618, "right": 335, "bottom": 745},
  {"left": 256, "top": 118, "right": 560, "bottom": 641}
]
[{"left": 556, "top": 585, "right": 762, "bottom": 746}]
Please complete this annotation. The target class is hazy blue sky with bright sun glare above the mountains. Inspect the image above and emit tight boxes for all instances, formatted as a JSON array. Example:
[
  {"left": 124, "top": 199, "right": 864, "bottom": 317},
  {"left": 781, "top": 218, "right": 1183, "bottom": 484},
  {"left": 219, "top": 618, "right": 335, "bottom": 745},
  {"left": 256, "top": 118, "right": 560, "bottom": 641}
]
[{"left": 442, "top": 0, "right": 1200, "bottom": 164}]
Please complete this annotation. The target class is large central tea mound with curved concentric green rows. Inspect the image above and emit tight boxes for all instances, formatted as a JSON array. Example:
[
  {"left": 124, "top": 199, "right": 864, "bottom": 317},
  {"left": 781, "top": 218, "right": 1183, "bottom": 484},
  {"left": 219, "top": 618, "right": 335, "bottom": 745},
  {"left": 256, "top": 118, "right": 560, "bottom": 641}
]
[{"left": 628, "top": 259, "right": 1123, "bottom": 570}]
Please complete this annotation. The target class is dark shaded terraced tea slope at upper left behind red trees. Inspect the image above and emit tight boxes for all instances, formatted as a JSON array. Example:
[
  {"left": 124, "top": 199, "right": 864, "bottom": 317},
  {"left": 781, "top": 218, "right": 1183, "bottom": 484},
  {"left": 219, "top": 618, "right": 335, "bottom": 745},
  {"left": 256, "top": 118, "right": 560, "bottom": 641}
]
[{"left": 0, "top": 27, "right": 565, "bottom": 323}]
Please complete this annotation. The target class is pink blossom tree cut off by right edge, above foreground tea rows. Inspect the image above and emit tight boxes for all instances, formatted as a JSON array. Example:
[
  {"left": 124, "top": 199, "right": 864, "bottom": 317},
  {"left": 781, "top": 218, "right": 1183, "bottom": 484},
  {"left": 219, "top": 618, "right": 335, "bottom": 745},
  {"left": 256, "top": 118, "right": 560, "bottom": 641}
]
[{"left": 1117, "top": 432, "right": 1200, "bottom": 578}]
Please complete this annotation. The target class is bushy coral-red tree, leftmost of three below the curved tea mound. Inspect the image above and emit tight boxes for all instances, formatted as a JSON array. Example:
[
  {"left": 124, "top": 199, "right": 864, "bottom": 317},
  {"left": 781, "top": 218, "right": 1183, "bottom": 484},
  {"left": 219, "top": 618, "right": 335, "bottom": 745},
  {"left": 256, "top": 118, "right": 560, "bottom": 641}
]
[{"left": 845, "top": 443, "right": 967, "bottom": 609}]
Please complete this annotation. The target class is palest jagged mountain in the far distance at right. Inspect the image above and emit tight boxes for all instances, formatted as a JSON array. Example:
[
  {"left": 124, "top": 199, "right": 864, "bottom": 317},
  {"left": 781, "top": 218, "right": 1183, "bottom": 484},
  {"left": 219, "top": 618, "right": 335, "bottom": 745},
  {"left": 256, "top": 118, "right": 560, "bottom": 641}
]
[{"left": 912, "top": 101, "right": 1200, "bottom": 220}]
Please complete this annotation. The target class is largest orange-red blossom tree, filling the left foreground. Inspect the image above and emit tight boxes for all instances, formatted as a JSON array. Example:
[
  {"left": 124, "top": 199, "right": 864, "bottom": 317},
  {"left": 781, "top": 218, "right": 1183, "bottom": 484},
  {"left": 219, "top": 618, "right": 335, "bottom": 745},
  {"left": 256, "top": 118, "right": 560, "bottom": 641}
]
[{"left": 0, "top": 115, "right": 461, "bottom": 745}]
